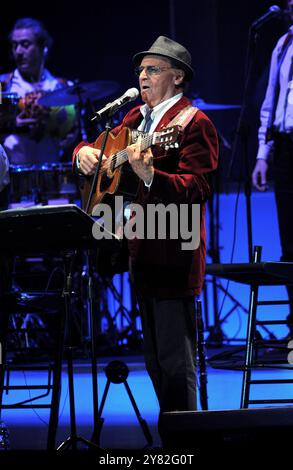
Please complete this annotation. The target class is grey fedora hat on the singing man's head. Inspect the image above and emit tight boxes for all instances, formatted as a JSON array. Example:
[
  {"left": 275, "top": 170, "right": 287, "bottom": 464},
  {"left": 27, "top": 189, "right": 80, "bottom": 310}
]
[{"left": 132, "top": 36, "right": 193, "bottom": 80}]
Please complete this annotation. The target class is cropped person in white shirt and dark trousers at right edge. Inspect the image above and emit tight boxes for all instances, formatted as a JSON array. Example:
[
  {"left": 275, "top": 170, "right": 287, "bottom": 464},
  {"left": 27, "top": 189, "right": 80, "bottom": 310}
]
[{"left": 252, "top": 0, "right": 293, "bottom": 338}]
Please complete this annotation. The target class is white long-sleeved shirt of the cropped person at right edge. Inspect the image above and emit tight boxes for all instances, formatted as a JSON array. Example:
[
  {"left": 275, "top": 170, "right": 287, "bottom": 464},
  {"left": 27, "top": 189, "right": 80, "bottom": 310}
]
[{"left": 257, "top": 25, "right": 293, "bottom": 160}]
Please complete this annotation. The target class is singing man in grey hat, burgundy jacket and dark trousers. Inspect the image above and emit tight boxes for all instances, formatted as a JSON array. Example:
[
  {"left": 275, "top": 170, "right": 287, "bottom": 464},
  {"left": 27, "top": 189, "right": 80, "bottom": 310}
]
[{"left": 74, "top": 36, "right": 218, "bottom": 440}]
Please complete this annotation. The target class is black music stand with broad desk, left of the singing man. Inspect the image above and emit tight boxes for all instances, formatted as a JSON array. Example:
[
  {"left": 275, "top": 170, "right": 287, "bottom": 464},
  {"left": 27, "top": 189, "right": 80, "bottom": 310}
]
[{"left": 0, "top": 204, "right": 120, "bottom": 450}]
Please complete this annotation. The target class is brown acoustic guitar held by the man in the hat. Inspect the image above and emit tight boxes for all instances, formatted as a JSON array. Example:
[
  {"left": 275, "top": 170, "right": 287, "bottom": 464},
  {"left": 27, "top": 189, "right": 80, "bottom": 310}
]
[{"left": 80, "top": 126, "right": 180, "bottom": 214}]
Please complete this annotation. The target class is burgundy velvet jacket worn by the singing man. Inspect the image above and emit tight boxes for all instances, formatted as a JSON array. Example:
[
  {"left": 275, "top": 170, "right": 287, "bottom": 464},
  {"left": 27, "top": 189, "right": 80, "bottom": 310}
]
[{"left": 73, "top": 97, "right": 218, "bottom": 299}]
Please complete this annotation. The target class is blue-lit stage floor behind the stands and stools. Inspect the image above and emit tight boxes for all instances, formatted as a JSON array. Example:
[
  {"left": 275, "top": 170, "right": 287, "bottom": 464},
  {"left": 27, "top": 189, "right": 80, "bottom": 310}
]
[{"left": 2, "top": 349, "right": 293, "bottom": 450}]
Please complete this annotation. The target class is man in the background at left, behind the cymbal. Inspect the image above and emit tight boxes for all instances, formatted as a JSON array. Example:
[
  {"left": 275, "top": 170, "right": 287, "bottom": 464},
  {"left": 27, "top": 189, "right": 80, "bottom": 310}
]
[{"left": 0, "top": 18, "right": 77, "bottom": 164}]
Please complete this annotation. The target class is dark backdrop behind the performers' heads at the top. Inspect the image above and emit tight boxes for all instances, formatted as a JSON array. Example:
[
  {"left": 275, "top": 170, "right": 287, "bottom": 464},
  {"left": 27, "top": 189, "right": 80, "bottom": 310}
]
[{"left": 0, "top": 0, "right": 286, "bottom": 183}]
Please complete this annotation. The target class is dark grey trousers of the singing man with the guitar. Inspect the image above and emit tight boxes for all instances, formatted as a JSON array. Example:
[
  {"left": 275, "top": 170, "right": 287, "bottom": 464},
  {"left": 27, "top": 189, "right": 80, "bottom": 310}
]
[{"left": 139, "top": 297, "right": 196, "bottom": 412}]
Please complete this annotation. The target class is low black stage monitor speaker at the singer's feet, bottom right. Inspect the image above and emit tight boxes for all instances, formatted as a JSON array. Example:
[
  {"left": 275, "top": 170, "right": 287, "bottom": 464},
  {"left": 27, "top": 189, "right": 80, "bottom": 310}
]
[{"left": 160, "top": 406, "right": 293, "bottom": 454}]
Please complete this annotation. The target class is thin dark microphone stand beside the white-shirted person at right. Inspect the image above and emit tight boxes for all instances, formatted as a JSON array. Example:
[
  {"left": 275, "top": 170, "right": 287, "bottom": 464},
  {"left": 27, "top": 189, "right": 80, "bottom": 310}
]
[{"left": 227, "top": 26, "right": 258, "bottom": 263}]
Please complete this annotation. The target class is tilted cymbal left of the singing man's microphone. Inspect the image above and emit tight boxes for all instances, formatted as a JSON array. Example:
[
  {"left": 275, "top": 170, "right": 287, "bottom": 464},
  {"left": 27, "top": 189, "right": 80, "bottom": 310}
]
[{"left": 38, "top": 80, "right": 119, "bottom": 106}]
